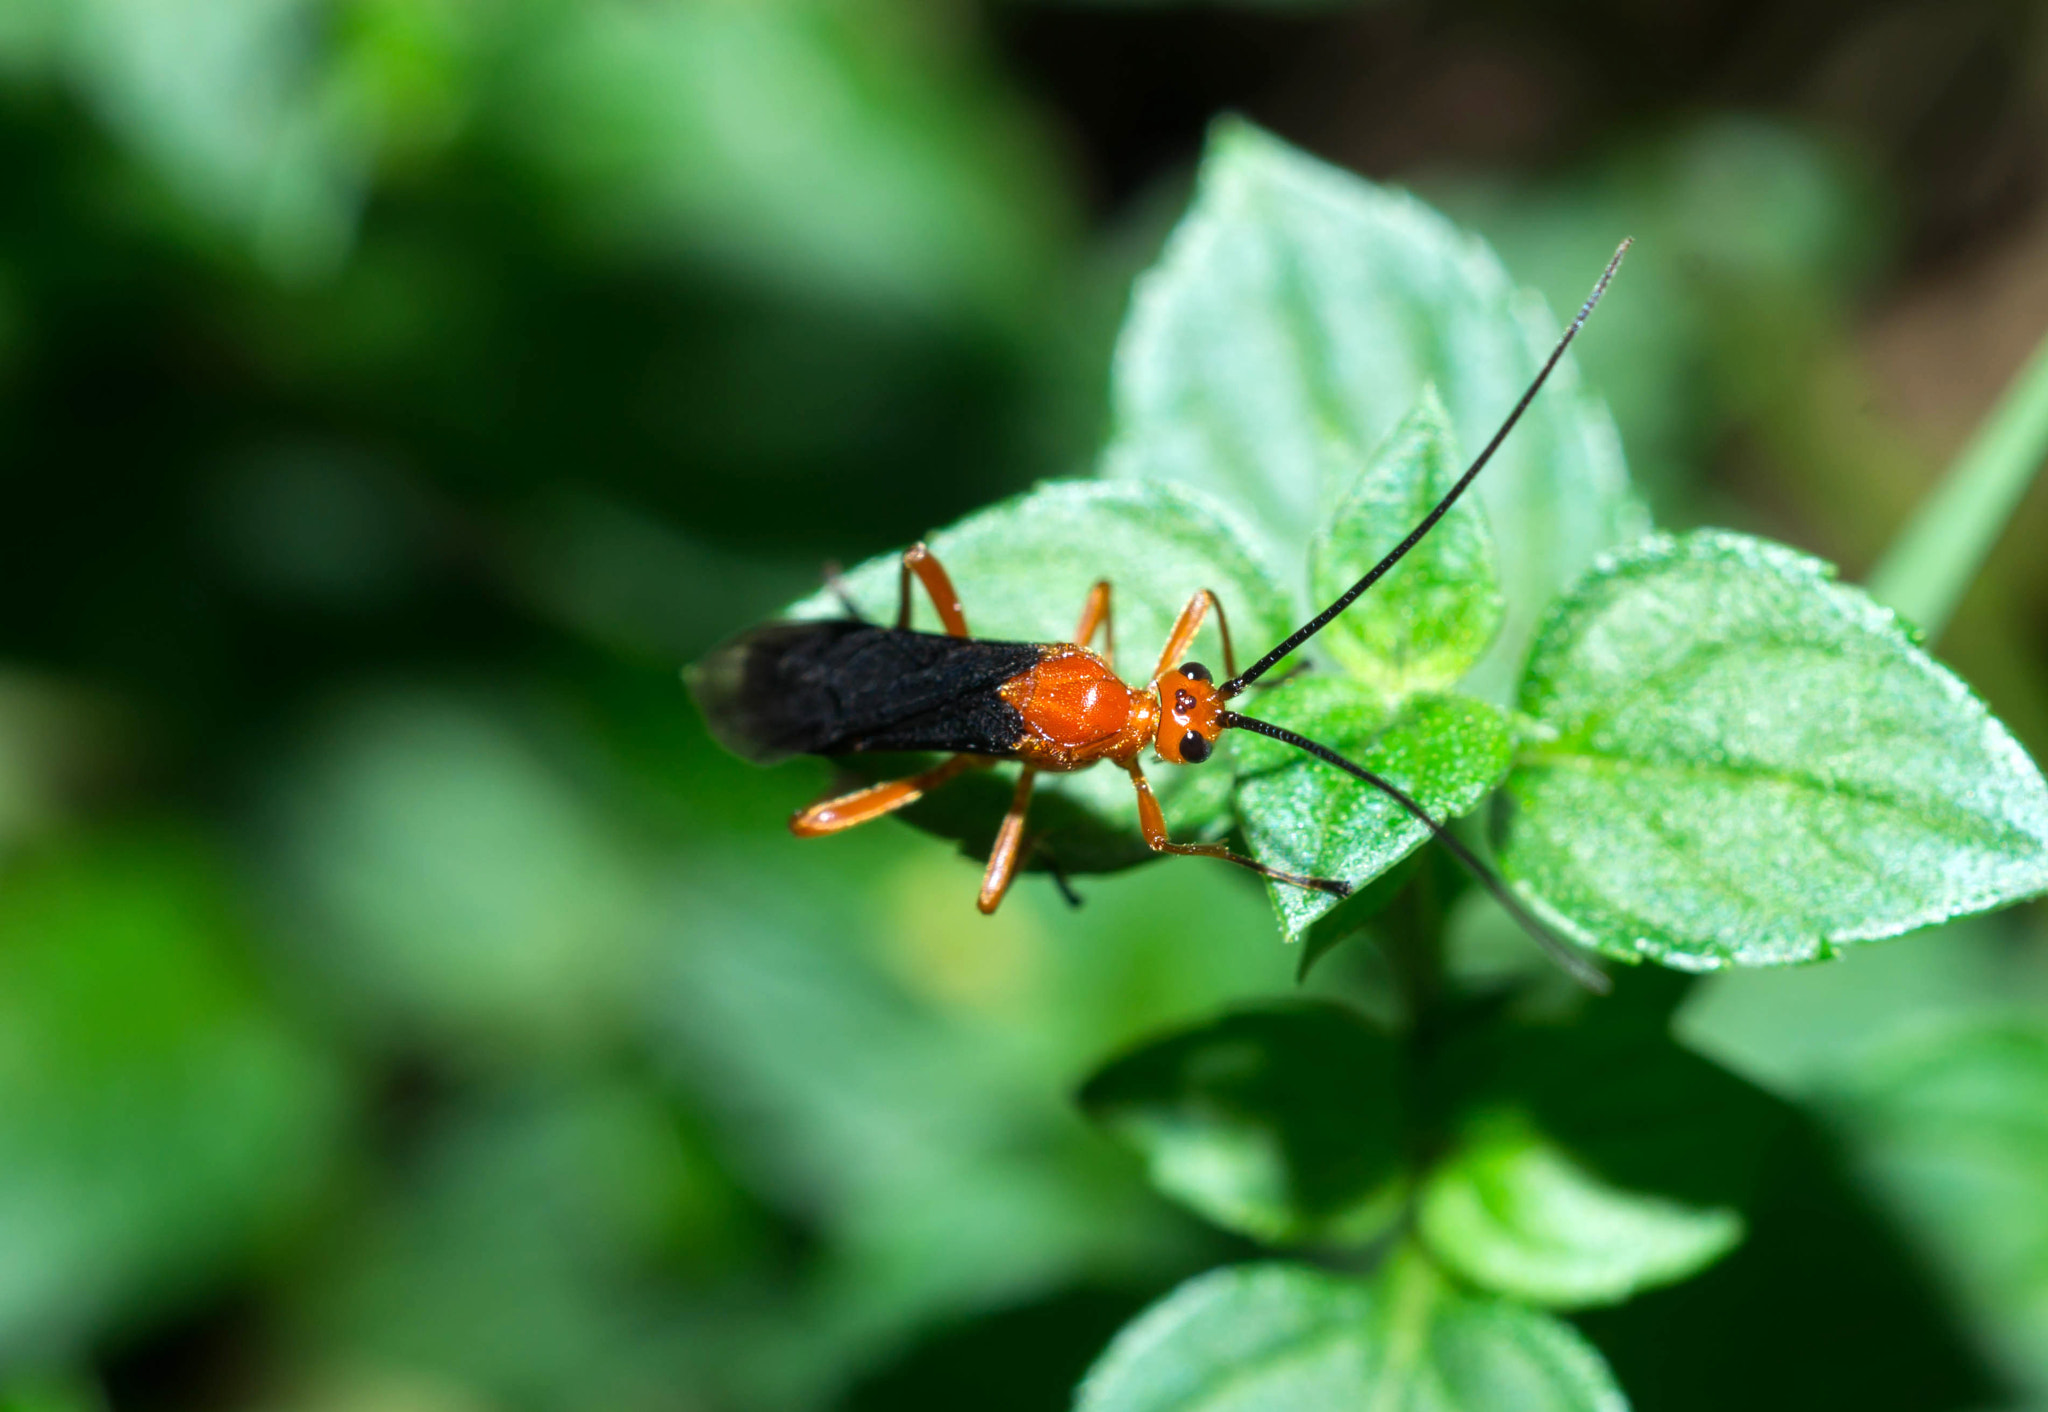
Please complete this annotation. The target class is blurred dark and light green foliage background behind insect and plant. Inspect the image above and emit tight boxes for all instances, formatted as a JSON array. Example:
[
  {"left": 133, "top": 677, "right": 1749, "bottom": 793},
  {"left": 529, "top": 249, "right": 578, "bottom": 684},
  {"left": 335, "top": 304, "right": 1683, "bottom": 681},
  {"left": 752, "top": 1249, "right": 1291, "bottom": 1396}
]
[{"left": 12, "top": 0, "right": 2048, "bottom": 1412}]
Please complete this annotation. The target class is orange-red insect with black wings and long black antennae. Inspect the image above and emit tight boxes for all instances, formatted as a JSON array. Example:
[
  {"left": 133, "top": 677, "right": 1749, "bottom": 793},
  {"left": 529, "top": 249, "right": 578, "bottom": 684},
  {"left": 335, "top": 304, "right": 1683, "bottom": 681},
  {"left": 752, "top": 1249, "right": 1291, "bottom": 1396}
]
[{"left": 686, "top": 240, "right": 1630, "bottom": 984}]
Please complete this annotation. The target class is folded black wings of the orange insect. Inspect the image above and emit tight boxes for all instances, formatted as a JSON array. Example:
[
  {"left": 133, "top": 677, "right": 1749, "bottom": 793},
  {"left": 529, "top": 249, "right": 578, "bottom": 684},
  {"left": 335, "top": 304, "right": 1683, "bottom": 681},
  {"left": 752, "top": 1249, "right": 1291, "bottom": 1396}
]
[{"left": 684, "top": 619, "right": 1040, "bottom": 764}]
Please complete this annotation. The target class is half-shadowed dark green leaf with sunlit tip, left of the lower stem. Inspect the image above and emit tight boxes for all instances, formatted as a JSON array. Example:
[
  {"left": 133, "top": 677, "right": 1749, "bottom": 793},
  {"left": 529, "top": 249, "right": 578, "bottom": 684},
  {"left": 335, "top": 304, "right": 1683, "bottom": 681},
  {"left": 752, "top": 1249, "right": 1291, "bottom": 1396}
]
[{"left": 1081, "top": 1000, "right": 1403, "bottom": 1242}]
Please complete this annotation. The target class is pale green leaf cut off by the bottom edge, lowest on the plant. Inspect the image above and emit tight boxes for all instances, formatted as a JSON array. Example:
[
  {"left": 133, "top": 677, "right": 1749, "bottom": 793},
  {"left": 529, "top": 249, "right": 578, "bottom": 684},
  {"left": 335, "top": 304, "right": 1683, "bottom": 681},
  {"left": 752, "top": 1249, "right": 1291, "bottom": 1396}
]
[{"left": 1075, "top": 1252, "right": 1628, "bottom": 1412}]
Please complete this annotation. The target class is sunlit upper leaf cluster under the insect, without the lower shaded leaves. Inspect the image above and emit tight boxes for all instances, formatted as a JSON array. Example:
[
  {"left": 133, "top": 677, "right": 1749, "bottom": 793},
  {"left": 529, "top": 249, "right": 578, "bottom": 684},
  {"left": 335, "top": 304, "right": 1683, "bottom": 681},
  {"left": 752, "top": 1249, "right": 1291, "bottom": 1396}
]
[{"left": 797, "top": 123, "right": 2048, "bottom": 971}]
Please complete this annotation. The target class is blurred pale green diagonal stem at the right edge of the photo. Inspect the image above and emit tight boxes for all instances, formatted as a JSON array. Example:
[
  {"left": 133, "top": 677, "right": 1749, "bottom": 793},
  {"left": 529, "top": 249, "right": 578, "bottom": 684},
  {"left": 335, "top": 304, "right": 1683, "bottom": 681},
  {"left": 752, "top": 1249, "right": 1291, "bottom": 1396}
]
[{"left": 1870, "top": 325, "right": 2048, "bottom": 641}]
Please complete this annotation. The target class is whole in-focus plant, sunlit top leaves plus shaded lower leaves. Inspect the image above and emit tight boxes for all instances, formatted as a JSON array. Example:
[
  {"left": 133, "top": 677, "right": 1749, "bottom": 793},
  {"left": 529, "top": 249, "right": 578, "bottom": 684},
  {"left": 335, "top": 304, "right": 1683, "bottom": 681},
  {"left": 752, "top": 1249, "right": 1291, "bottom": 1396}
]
[{"left": 757, "top": 123, "right": 2048, "bottom": 1412}]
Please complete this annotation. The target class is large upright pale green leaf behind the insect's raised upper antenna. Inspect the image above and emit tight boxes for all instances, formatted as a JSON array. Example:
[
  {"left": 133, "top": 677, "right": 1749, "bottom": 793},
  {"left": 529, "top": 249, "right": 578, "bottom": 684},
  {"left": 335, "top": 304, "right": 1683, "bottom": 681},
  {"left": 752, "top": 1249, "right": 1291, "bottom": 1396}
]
[{"left": 1104, "top": 121, "right": 1647, "bottom": 703}]
